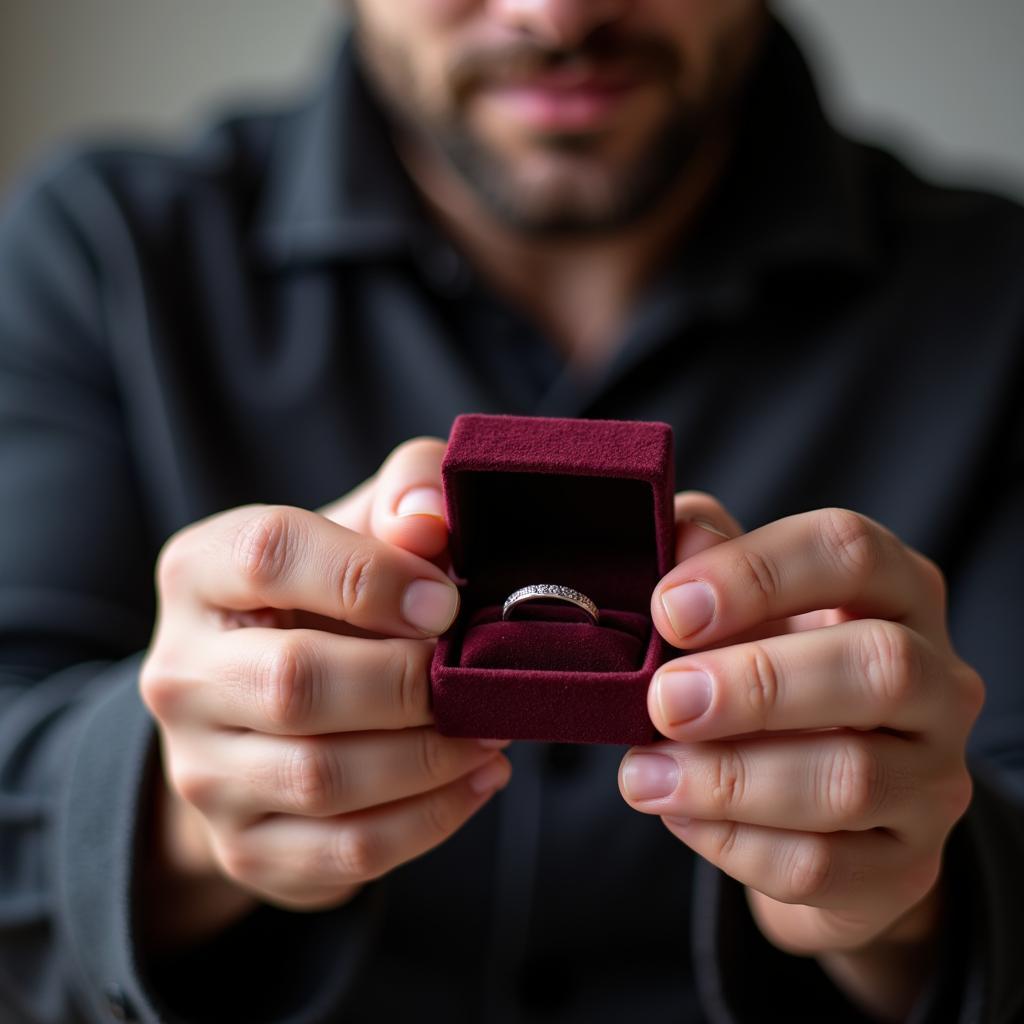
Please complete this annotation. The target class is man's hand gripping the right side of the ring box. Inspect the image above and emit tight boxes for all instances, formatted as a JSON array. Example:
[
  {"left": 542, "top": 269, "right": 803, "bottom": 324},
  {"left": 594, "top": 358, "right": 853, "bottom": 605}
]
[{"left": 618, "top": 493, "right": 984, "bottom": 1020}]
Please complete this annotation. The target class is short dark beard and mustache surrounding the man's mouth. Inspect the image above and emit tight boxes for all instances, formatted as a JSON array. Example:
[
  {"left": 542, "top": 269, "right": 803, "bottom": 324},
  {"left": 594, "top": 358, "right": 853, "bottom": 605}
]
[{"left": 353, "top": 17, "right": 757, "bottom": 238}]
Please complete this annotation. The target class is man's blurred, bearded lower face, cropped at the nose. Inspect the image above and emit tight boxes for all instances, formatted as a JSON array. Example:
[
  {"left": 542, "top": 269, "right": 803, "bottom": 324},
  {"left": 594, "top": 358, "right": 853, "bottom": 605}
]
[{"left": 350, "top": 0, "right": 764, "bottom": 234}]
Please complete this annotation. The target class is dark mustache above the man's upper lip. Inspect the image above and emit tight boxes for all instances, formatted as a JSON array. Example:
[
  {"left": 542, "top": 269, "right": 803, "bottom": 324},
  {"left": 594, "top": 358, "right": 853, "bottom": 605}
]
[{"left": 447, "top": 31, "right": 680, "bottom": 101}]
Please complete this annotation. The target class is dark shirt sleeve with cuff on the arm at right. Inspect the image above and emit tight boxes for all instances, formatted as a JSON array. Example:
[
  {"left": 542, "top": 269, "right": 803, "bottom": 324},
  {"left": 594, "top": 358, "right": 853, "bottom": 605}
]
[{"left": 693, "top": 378, "right": 1024, "bottom": 1024}]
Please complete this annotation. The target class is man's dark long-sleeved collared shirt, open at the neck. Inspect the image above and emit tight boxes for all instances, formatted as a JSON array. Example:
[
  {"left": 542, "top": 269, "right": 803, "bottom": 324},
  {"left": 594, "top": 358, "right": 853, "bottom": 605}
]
[{"left": 0, "top": 16, "right": 1024, "bottom": 1024}]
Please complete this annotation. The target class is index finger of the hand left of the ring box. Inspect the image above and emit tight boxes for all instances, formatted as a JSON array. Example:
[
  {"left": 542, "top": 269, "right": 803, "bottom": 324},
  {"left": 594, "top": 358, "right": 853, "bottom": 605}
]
[{"left": 158, "top": 505, "right": 459, "bottom": 637}]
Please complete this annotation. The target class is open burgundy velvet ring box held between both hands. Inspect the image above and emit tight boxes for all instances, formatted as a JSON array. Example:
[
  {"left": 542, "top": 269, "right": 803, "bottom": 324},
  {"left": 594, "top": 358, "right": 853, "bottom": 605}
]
[{"left": 430, "top": 413, "right": 675, "bottom": 743}]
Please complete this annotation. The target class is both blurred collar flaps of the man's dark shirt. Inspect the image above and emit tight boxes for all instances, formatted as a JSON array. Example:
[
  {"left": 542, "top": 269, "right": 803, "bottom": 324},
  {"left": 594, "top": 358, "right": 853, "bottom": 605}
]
[{"left": 255, "top": 22, "right": 876, "bottom": 285}]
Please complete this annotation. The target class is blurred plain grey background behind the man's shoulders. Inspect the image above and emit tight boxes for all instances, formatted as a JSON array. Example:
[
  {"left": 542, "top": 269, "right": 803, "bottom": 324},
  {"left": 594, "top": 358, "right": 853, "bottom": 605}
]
[{"left": 0, "top": 0, "right": 1024, "bottom": 200}]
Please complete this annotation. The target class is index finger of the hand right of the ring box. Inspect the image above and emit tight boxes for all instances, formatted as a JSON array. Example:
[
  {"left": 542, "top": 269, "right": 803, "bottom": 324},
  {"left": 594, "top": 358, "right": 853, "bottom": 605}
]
[{"left": 650, "top": 509, "right": 945, "bottom": 648}]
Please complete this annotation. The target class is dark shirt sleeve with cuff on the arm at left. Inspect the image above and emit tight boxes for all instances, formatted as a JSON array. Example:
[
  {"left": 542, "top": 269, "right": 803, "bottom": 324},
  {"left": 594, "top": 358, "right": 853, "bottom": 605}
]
[{"left": 0, "top": 158, "right": 379, "bottom": 1024}]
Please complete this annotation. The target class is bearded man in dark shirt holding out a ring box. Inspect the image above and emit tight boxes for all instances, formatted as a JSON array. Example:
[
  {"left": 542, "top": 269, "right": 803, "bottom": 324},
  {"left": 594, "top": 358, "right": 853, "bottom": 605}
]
[{"left": 0, "top": 0, "right": 1024, "bottom": 1022}]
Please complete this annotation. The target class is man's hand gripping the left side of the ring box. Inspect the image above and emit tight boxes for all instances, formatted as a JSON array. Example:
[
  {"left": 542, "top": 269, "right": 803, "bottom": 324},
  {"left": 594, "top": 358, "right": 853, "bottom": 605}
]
[{"left": 139, "top": 437, "right": 511, "bottom": 953}]
